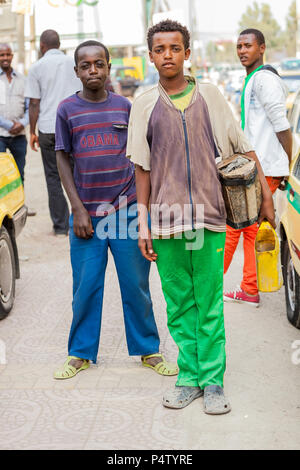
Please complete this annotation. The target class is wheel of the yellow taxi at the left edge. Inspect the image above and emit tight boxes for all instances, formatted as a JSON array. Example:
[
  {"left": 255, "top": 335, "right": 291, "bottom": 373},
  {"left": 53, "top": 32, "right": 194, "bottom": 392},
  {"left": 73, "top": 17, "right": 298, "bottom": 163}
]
[{"left": 0, "top": 227, "right": 16, "bottom": 320}]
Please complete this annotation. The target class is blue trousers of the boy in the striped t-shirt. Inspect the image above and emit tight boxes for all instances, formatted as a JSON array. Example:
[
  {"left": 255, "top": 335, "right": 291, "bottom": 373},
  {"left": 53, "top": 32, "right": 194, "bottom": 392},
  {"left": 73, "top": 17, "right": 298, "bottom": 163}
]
[{"left": 68, "top": 204, "right": 160, "bottom": 362}]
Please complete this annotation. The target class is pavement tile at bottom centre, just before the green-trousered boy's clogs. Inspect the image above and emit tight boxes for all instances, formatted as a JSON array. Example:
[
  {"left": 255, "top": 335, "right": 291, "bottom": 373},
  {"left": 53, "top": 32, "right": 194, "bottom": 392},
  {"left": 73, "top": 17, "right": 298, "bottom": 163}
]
[{"left": 85, "top": 388, "right": 182, "bottom": 450}]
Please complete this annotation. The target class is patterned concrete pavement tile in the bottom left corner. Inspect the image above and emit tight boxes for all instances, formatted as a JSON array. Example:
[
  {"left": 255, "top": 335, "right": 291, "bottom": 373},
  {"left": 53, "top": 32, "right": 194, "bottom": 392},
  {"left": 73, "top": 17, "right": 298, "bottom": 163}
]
[{"left": 0, "top": 390, "right": 101, "bottom": 450}]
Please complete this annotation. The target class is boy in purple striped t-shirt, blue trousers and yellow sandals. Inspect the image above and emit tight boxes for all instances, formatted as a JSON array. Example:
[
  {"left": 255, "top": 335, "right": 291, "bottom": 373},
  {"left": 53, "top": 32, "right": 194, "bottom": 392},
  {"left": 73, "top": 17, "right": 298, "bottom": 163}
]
[{"left": 54, "top": 41, "right": 178, "bottom": 379}]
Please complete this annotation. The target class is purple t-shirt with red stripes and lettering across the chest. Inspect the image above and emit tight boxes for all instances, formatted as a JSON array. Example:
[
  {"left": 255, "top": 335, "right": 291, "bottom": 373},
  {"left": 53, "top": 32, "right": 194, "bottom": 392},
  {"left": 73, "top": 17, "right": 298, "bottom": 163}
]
[{"left": 55, "top": 92, "right": 136, "bottom": 217}]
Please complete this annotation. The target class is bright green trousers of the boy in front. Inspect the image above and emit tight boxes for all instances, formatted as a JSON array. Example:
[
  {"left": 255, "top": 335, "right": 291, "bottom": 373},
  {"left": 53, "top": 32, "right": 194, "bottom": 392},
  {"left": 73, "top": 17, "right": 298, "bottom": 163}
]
[{"left": 153, "top": 229, "right": 226, "bottom": 388}]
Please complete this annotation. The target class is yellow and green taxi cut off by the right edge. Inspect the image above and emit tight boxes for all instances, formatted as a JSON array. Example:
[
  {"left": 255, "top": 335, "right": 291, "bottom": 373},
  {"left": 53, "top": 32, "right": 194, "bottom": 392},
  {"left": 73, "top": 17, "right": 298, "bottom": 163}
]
[{"left": 276, "top": 152, "right": 300, "bottom": 328}]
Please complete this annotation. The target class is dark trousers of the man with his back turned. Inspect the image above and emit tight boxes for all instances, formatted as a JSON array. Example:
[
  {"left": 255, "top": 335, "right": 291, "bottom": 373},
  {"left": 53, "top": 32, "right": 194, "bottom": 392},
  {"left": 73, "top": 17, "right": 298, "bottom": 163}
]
[{"left": 39, "top": 132, "right": 70, "bottom": 234}]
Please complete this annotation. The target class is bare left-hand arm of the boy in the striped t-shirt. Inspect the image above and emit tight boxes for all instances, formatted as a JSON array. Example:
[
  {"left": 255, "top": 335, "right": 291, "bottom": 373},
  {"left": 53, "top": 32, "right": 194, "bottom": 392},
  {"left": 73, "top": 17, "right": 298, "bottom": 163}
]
[{"left": 56, "top": 150, "right": 94, "bottom": 240}]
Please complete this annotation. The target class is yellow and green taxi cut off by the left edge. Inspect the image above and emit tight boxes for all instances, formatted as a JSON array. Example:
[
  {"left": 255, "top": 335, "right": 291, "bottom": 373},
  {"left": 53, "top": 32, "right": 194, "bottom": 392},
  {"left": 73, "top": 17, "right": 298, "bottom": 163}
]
[{"left": 0, "top": 153, "right": 27, "bottom": 320}]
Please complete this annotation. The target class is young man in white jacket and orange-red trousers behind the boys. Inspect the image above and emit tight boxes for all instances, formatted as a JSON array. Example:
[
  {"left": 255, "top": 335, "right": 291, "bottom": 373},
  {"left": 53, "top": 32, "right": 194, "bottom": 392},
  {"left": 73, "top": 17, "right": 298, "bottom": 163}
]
[{"left": 224, "top": 29, "right": 292, "bottom": 307}]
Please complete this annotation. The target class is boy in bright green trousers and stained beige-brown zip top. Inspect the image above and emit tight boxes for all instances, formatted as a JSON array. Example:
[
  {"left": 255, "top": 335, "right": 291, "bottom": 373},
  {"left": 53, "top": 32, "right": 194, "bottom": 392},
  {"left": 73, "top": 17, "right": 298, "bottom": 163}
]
[{"left": 127, "top": 20, "right": 274, "bottom": 414}]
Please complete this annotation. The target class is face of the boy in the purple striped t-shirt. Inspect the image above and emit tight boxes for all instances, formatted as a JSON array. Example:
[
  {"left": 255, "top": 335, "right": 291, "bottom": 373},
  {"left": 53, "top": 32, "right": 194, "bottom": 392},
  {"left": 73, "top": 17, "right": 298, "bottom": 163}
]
[{"left": 75, "top": 46, "right": 110, "bottom": 90}]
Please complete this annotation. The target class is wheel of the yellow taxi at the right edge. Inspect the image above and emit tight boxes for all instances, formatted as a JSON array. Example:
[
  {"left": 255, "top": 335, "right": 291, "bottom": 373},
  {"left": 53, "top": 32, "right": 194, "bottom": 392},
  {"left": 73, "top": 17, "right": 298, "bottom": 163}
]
[{"left": 283, "top": 240, "right": 300, "bottom": 328}]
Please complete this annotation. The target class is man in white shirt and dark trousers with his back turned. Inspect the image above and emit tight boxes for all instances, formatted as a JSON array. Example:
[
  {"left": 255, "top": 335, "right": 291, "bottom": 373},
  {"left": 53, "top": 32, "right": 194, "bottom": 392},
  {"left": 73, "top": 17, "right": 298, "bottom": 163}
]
[{"left": 25, "top": 29, "right": 81, "bottom": 235}]
